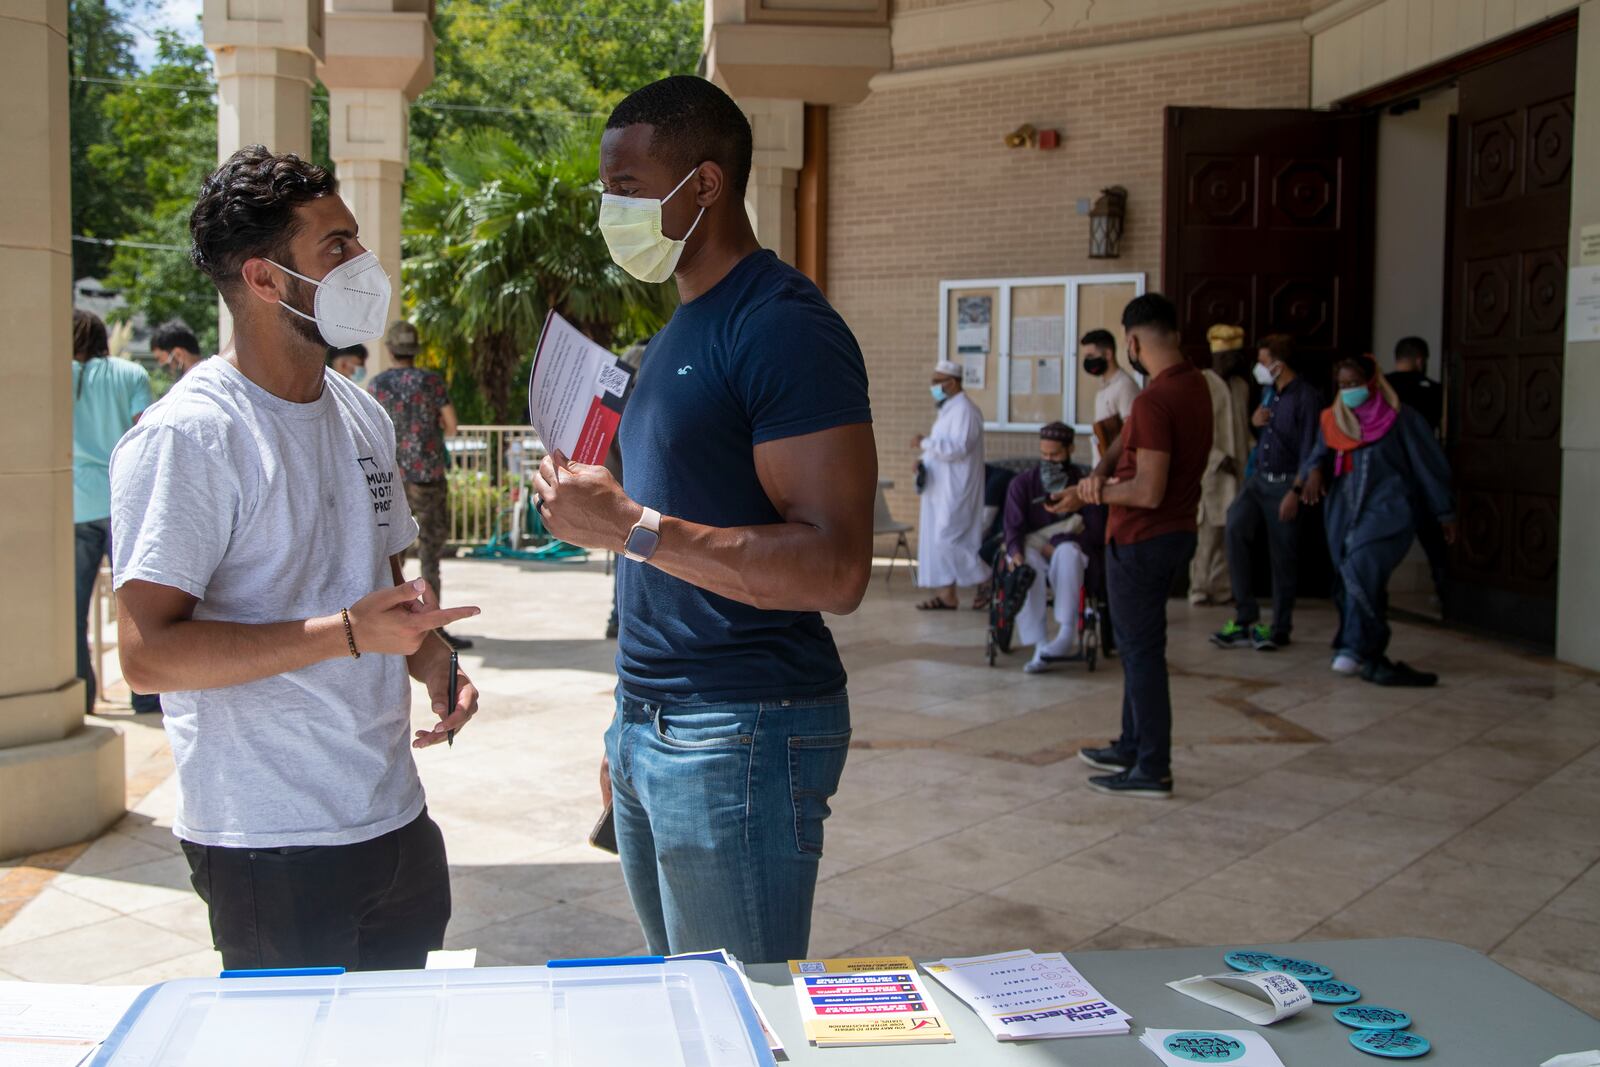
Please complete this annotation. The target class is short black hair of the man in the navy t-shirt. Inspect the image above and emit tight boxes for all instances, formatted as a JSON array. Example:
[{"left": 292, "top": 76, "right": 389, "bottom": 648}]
[{"left": 605, "top": 74, "right": 752, "bottom": 197}]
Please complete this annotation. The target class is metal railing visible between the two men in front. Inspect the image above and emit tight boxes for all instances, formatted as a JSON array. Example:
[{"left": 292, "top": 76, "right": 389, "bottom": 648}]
[{"left": 445, "top": 426, "right": 544, "bottom": 547}]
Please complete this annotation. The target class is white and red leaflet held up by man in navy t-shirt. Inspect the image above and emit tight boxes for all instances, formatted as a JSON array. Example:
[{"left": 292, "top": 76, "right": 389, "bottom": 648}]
[{"left": 528, "top": 312, "right": 634, "bottom": 464}]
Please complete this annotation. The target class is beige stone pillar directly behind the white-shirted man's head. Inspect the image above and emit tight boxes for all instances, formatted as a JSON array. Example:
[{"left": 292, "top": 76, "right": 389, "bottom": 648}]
[{"left": 203, "top": 0, "right": 323, "bottom": 349}]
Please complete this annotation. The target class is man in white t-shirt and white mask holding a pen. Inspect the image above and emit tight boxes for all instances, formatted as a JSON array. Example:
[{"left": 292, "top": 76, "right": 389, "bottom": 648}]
[{"left": 110, "top": 146, "right": 477, "bottom": 969}]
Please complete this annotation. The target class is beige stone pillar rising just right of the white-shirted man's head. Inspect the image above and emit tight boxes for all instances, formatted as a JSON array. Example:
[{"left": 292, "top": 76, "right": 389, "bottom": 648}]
[{"left": 317, "top": 0, "right": 434, "bottom": 374}]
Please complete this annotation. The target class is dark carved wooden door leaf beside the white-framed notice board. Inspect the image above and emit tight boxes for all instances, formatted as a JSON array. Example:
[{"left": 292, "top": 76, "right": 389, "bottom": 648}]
[{"left": 1162, "top": 107, "right": 1378, "bottom": 385}]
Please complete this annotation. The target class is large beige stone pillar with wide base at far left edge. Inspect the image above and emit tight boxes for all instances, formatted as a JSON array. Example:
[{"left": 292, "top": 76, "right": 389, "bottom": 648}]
[{"left": 0, "top": 0, "right": 125, "bottom": 859}]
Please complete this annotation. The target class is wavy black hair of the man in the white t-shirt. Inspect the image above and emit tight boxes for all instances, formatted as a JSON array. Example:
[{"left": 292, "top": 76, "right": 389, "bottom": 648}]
[{"left": 189, "top": 144, "right": 339, "bottom": 294}]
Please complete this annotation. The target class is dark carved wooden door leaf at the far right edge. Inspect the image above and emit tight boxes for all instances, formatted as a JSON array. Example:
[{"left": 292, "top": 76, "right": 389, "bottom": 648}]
[{"left": 1445, "top": 32, "right": 1578, "bottom": 645}]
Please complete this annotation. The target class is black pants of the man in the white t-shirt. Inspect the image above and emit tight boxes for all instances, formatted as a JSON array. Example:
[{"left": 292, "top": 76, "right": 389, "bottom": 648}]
[{"left": 182, "top": 809, "right": 450, "bottom": 971}]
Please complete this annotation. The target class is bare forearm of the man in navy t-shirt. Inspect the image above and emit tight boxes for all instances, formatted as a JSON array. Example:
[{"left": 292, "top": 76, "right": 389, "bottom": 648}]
[{"left": 650, "top": 517, "right": 872, "bottom": 614}]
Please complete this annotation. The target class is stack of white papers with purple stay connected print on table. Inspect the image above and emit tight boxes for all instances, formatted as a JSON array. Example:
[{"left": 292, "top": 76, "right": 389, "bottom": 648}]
[{"left": 925, "top": 949, "right": 1131, "bottom": 1041}]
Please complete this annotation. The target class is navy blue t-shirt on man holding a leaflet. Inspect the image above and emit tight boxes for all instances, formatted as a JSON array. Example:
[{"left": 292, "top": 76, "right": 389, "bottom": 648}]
[{"left": 616, "top": 250, "right": 872, "bottom": 704}]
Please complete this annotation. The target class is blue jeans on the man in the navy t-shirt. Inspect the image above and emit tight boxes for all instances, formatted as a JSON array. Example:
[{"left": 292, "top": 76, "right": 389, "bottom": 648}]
[{"left": 605, "top": 691, "right": 850, "bottom": 963}]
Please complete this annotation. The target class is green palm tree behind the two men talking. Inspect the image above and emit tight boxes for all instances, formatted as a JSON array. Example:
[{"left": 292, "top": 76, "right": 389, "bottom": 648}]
[{"left": 403, "top": 130, "right": 677, "bottom": 422}]
